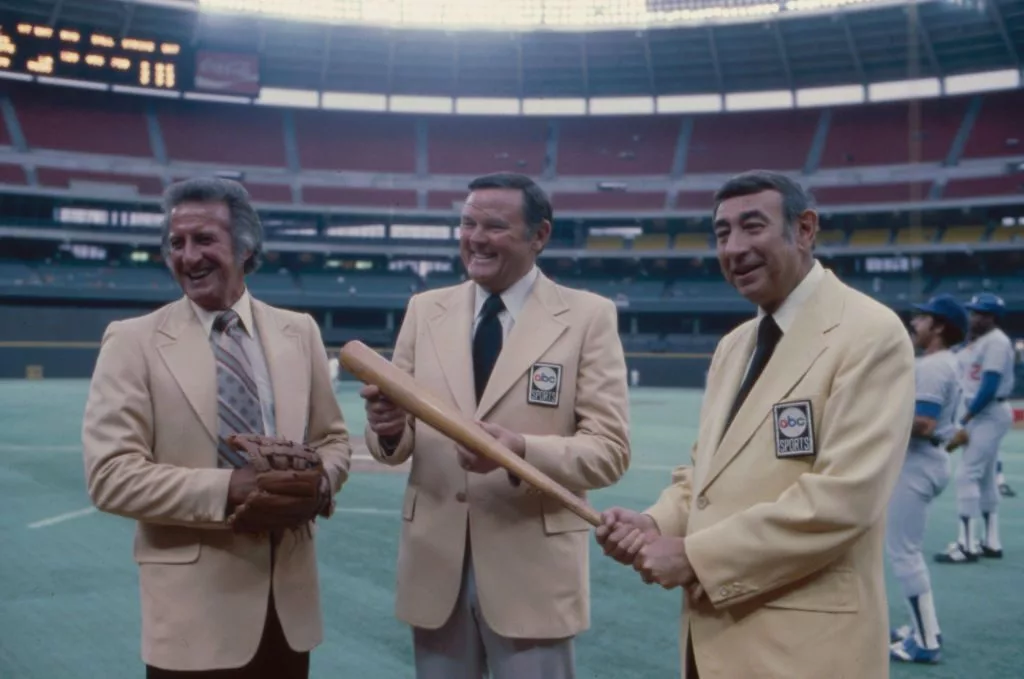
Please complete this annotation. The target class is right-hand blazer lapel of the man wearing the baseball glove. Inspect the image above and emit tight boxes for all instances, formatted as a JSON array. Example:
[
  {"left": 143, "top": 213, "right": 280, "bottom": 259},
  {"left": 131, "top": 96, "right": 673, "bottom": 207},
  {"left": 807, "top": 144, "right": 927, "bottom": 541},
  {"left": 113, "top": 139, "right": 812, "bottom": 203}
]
[{"left": 250, "top": 299, "right": 309, "bottom": 441}]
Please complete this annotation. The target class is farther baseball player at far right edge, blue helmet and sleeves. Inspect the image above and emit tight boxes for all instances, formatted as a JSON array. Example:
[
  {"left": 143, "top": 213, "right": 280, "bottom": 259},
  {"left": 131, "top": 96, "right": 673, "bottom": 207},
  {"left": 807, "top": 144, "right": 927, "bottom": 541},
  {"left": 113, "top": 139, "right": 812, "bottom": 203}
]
[{"left": 935, "top": 293, "right": 1014, "bottom": 563}]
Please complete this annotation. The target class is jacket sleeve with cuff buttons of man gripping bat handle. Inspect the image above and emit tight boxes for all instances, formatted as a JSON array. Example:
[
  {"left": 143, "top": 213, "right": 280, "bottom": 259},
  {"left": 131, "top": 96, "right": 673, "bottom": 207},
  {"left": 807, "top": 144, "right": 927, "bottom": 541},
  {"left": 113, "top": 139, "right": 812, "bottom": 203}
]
[{"left": 686, "top": 317, "right": 914, "bottom": 608}]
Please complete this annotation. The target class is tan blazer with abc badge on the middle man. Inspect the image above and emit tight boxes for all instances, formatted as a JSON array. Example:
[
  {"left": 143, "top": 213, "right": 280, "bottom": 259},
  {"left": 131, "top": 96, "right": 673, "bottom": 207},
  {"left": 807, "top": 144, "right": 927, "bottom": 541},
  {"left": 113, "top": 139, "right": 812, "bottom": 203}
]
[{"left": 367, "top": 274, "right": 630, "bottom": 639}]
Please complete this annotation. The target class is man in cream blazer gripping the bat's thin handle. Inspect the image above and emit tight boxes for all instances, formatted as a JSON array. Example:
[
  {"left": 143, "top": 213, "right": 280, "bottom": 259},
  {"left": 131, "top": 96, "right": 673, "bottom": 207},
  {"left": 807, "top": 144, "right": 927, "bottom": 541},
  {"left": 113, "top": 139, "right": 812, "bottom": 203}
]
[{"left": 597, "top": 172, "right": 914, "bottom": 679}]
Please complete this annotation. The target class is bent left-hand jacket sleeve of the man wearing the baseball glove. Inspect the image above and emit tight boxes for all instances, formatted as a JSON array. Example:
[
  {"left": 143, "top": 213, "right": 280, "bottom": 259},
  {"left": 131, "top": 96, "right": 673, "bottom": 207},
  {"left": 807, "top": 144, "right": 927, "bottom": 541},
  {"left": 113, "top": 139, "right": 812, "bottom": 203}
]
[{"left": 82, "top": 322, "right": 231, "bottom": 528}]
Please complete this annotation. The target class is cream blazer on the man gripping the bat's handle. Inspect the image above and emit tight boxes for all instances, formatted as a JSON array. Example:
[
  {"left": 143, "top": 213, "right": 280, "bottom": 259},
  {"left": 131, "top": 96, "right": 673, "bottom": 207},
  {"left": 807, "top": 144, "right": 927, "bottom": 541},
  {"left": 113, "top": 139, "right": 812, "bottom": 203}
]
[{"left": 647, "top": 271, "right": 914, "bottom": 679}]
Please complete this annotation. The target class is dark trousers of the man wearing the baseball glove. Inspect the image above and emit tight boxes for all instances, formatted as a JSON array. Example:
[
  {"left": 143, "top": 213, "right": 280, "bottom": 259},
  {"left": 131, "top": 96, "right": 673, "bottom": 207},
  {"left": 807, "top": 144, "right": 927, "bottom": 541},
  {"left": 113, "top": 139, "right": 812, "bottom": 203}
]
[{"left": 145, "top": 592, "right": 309, "bottom": 679}]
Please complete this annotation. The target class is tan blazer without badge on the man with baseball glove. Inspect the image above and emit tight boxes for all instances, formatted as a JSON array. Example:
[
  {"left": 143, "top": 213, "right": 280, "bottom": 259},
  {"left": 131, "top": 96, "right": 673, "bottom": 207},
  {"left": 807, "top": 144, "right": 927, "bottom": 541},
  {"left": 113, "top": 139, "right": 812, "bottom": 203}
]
[{"left": 82, "top": 298, "right": 350, "bottom": 670}]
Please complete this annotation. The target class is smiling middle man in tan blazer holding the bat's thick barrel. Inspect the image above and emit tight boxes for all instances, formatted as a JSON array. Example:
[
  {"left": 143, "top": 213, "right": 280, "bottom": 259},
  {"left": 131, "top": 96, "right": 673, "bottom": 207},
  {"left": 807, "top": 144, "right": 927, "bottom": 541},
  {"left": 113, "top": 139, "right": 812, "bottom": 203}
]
[{"left": 362, "top": 174, "right": 630, "bottom": 679}]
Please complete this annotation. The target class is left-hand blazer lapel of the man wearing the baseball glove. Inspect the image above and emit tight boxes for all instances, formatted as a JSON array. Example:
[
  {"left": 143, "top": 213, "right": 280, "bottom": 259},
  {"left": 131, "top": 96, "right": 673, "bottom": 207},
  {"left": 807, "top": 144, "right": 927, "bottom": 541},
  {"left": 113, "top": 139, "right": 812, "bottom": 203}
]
[{"left": 157, "top": 297, "right": 217, "bottom": 444}]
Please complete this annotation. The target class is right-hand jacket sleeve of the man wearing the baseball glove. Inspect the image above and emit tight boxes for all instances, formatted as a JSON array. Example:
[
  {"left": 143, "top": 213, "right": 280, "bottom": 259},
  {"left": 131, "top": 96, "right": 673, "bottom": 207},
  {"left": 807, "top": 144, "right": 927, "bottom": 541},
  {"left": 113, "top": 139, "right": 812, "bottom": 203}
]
[{"left": 305, "top": 314, "right": 352, "bottom": 495}]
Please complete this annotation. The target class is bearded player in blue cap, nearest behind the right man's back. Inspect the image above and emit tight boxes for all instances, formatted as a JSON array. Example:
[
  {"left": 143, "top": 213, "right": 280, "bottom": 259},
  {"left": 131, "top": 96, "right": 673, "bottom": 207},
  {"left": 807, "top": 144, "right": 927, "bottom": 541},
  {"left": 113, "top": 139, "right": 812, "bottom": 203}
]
[{"left": 886, "top": 295, "right": 968, "bottom": 664}]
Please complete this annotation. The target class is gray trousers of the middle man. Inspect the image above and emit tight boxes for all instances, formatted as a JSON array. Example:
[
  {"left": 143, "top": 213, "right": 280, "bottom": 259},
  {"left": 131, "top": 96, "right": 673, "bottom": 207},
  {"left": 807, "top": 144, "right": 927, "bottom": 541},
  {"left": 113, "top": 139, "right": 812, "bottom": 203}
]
[{"left": 413, "top": 546, "right": 575, "bottom": 679}]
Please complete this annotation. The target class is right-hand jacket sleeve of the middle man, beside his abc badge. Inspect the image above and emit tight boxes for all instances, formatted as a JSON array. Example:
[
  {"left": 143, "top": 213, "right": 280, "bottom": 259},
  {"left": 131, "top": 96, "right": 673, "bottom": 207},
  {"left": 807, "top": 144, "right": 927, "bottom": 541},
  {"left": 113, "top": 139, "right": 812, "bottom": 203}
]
[{"left": 523, "top": 300, "right": 630, "bottom": 493}]
